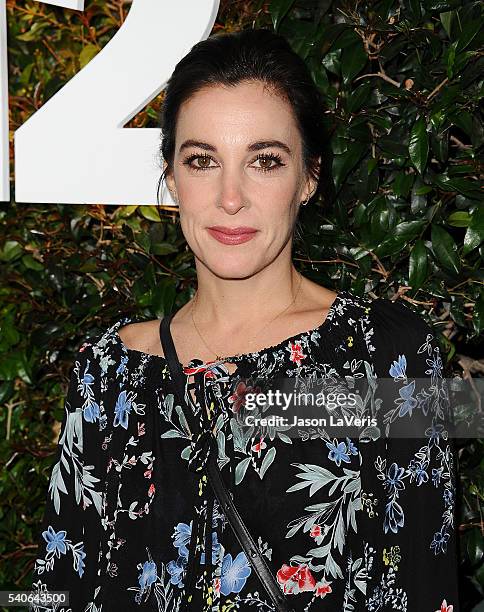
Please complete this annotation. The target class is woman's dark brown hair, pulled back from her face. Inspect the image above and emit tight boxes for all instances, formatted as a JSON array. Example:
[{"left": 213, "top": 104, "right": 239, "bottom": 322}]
[{"left": 157, "top": 29, "right": 334, "bottom": 220}]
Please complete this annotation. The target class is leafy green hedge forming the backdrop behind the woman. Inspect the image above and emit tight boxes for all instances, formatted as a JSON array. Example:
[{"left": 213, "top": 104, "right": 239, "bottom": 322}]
[{"left": 0, "top": 0, "right": 484, "bottom": 612}]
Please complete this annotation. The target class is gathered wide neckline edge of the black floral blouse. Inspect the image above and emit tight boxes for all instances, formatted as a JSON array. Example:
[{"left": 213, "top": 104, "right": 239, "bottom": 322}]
[{"left": 111, "top": 289, "right": 352, "bottom": 371}]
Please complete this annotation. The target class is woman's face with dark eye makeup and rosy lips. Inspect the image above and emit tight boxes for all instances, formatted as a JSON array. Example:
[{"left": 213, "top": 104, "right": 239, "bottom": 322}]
[{"left": 165, "top": 81, "right": 316, "bottom": 278}]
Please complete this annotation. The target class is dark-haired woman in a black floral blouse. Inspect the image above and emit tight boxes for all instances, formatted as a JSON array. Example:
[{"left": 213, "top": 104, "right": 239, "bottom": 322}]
[{"left": 28, "top": 30, "right": 459, "bottom": 612}]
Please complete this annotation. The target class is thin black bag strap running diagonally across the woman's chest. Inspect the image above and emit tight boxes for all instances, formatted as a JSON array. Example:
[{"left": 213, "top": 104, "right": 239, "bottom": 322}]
[{"left": 160, "top": 314, "right": 294, "bottom": 612}]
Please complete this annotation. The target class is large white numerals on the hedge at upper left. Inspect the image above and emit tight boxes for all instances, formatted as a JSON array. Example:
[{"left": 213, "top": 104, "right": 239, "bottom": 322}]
[{"left": 0, "top": 0, "right": 219, "bottom": 204}]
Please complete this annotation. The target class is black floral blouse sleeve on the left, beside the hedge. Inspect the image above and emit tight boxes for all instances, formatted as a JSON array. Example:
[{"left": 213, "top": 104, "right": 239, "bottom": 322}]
[{"left": 30, "top": 342, "right": 102, "bottom": 612}]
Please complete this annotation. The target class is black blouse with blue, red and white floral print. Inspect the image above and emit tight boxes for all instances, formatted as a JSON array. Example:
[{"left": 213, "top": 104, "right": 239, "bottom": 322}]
[{"left": 30, "top": 291, "right": 460, "bottom": 612}]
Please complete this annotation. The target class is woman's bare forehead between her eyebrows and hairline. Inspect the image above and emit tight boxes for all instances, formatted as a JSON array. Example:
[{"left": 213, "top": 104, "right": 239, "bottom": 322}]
[{"left": 176, "top": 81, "right": 300, "bottom": 145}]
